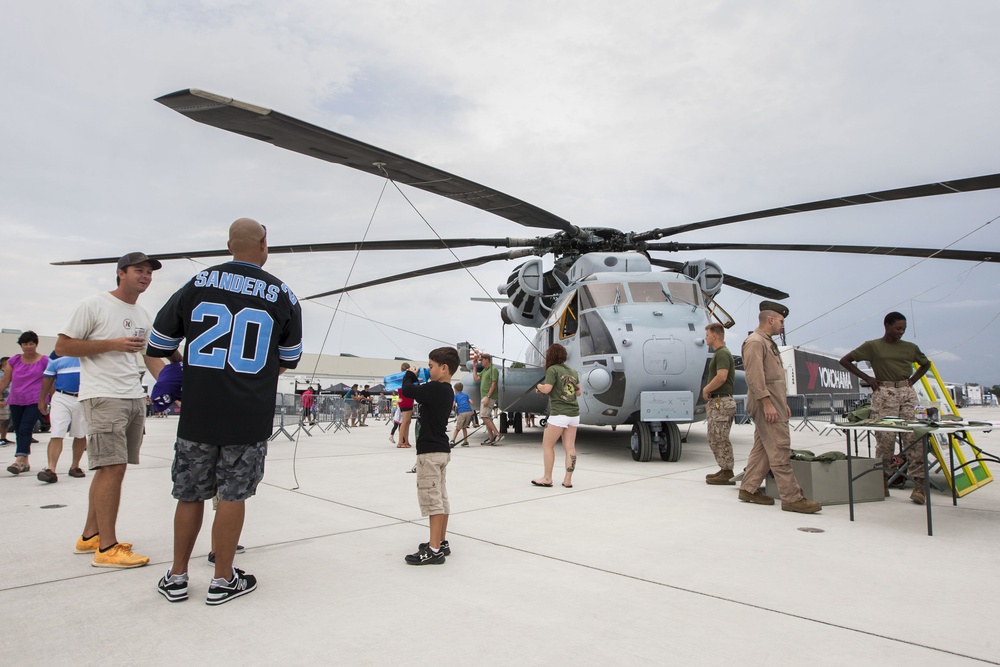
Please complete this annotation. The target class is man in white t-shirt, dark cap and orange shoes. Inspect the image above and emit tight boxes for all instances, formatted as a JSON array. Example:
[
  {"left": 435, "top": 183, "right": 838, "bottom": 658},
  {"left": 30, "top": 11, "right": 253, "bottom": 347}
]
[{"left": 56, "top": 252, "right": 163, "bottom": 568}]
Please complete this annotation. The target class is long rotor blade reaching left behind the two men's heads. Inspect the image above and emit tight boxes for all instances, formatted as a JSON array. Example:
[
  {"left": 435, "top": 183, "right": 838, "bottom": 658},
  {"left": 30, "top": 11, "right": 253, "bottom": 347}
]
[{"left": 52, "top": 238, "right": 539, "bottom": 266}]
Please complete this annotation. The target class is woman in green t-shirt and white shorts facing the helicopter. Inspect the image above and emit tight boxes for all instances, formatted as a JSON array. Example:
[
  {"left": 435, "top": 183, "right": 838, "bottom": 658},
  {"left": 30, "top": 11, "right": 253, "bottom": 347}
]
[{"left": 531, "top": 343, "right": 582, "bottom": 489}]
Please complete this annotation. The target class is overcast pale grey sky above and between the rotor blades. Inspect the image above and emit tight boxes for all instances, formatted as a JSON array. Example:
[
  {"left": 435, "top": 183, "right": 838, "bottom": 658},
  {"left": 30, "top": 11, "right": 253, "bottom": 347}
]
[{"left": 0, "top": 0, "right": 1000, "bottom": 385}]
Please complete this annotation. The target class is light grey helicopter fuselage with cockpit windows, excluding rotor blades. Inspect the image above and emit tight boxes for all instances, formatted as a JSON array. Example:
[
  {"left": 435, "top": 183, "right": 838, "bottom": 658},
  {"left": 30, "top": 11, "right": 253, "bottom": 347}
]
[{"left": 470, "top": 253, "right": 711, "bottom": 456}]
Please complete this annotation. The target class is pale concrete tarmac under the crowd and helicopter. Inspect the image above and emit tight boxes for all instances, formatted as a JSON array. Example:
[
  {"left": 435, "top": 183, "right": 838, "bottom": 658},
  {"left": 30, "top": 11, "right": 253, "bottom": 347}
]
[{"left": 0, "top": 408, "right": 1000, "bottom": 667}]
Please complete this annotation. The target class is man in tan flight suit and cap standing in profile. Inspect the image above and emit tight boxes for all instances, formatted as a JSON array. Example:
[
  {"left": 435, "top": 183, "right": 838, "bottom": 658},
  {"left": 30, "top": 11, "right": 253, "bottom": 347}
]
[{"left": 739, "top": 301, "right": 823, "bottom": 514}]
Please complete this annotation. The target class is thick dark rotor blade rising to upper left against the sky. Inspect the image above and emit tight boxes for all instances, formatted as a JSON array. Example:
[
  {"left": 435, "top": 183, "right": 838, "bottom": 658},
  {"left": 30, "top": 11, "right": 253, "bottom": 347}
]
[{"left": 156, "top": 88, "right": 583, "bottom": 237}]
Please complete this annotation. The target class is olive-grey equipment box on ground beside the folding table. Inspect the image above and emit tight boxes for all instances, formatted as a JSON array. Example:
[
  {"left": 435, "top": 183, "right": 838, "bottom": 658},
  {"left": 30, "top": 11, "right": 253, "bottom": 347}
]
[{"left": 767, "top": 458, "right": 885, "bottom": 505}]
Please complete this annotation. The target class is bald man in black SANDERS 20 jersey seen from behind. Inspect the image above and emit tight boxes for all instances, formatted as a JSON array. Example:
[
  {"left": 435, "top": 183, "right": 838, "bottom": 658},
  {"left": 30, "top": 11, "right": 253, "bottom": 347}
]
[{"left": 147, "top": 218, "right": 302, "bottom": 605}]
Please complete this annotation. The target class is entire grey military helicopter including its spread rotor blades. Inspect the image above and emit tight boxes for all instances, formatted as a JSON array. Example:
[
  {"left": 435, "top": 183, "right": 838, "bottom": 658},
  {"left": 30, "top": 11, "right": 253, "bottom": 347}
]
[{"left": 54, "top": 89, "right": 1000, "bottom": 461}]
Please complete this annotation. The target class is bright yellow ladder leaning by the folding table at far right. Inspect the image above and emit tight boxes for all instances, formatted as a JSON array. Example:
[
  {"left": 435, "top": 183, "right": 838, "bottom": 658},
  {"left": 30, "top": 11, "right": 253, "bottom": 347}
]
[{"left": 913, "top": 361, "right": 993, "bottom": 497}]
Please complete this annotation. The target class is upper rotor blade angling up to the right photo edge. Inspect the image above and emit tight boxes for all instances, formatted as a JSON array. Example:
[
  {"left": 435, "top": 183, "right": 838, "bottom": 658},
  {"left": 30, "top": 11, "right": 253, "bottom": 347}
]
[{"left": 633, "top": 174, "right": 1000, "bottom": 241}]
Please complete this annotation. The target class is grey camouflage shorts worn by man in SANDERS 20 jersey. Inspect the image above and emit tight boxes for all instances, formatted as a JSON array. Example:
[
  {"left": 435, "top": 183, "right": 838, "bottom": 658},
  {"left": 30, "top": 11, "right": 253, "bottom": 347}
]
[{"left": 170, "top": 438, "right": 267, "bottom": 503}]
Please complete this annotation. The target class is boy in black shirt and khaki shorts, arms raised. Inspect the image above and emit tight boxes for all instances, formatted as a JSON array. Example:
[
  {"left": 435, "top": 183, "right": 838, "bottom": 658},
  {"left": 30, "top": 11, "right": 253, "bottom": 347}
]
[{"left": 399, "top": 347, "right": 459, "bottom": 565}]
